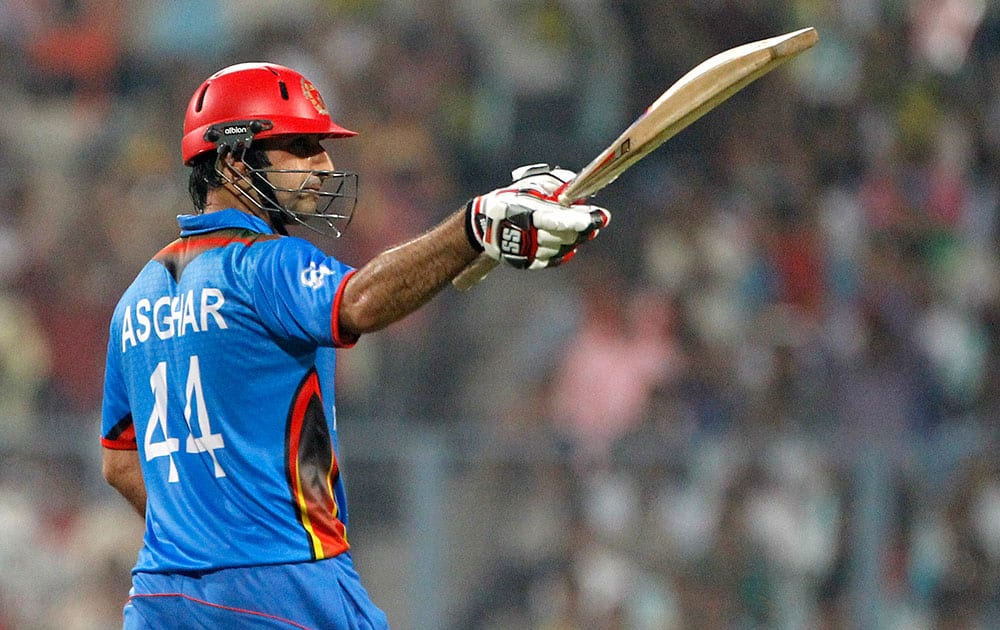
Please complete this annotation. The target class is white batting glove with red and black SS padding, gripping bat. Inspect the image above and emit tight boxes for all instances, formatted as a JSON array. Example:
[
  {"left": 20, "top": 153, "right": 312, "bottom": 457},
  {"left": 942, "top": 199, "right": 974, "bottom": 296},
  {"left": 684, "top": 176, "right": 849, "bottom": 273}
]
[{"left": 466, "top": 164, "right": 611, "bottom": 269}]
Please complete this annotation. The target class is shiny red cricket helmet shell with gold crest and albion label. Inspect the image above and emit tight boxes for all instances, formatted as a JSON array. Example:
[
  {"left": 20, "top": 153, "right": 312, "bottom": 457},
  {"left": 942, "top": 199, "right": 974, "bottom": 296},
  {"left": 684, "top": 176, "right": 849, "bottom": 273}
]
[{"left": 181, "top": 63, "right": 357, "bottom": 165}]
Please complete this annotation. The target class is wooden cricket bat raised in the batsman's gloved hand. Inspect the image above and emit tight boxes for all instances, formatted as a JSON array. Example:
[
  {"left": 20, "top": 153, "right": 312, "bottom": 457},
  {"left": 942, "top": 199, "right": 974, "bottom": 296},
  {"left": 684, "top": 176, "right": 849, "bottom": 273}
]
[{"left": 452, "top": 27, "right": 819, "bottom": 291}]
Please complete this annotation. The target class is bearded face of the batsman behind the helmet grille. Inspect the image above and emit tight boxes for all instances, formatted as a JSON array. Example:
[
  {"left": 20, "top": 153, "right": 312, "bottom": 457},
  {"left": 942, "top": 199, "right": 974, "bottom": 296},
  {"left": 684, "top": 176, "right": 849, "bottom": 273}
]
[{"left": 258, "top": 134, "right": 333, "bottom": 214}]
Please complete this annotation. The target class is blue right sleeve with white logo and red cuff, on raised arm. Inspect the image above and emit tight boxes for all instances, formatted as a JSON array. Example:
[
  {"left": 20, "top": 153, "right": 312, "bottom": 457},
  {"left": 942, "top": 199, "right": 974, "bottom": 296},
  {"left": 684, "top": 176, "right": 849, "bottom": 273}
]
[{"left": 253, "top": 238, "right": 357, "bottom": 347}]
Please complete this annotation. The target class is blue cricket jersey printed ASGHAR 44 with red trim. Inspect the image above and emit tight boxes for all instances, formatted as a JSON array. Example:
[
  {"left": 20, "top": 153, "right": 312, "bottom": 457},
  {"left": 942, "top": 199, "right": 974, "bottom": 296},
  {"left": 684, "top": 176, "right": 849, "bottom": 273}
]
[{"left": 101, "top": 209, "right": 355, "bottom": 573}]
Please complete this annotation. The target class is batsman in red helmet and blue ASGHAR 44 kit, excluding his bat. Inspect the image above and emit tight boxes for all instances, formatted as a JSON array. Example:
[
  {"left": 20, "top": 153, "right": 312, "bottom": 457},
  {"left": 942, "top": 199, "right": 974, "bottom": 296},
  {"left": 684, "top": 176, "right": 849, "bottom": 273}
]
[{"left": 101, "top": 63, "right": 610, "bottom": 629}]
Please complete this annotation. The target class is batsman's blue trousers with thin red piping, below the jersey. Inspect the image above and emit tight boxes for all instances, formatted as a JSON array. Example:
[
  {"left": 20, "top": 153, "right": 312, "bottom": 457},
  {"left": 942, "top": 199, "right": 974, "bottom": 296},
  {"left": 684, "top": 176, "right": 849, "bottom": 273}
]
[{"left": 123, "top": 553, "right": 388, "bottom": 630}]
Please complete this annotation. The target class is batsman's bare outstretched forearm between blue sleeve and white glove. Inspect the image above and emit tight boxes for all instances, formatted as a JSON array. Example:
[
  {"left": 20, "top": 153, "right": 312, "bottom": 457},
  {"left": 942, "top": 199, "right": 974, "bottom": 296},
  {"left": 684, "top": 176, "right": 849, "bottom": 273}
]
[{"left": 340, "top": 211, "right": 478, "bottom": 335}]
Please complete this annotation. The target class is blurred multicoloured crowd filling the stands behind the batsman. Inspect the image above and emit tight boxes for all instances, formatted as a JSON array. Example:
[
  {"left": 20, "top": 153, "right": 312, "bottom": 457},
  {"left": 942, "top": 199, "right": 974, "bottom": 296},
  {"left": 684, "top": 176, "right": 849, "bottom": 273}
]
[{"left": 0, "top": 0, "right": 1000, "bottom": 630}]
